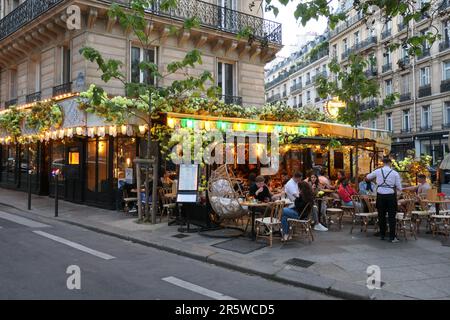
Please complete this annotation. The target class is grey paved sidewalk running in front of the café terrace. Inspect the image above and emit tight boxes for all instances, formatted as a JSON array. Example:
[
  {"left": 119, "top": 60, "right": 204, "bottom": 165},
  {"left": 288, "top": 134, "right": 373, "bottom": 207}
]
[{"left": 0, "top": 189, "right": 450, "bottom": 299}]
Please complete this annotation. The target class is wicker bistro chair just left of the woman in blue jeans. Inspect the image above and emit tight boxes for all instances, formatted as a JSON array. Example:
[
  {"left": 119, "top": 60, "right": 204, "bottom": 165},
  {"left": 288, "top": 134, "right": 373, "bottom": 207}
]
[{"left": 255, "top": 201, "right": 284, "bottom": 247}]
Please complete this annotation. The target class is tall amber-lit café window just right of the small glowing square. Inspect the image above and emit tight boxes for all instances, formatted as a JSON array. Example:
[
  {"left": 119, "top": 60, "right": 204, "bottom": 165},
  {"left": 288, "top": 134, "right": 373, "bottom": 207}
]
[{"left": 87, "top": 138, "right": 110, "bottom": 192}]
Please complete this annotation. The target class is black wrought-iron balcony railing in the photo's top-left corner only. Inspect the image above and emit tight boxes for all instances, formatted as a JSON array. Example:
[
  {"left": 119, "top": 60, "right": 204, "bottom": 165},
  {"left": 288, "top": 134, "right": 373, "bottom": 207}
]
[{"left": 0, "top": 0, "right": 64, "bottom": 40}]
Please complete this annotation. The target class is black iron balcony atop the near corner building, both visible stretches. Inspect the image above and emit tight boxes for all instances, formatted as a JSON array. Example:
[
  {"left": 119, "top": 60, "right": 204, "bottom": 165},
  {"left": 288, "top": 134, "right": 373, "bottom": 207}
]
[{"left": 0, "top": 0, "right": 282, "bottom": 45}]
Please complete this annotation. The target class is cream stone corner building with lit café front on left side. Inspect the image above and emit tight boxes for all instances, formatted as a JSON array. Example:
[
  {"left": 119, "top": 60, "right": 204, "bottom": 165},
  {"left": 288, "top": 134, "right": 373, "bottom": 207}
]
[{"left": 0, "top": 0, "right": 281, "bottom": 208}]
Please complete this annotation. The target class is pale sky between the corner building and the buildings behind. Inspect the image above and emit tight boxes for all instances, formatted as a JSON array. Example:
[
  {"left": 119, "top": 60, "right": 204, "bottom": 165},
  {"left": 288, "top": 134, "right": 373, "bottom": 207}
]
[{"left": 264, "top": 0, "right": 337, "bottom": 68}]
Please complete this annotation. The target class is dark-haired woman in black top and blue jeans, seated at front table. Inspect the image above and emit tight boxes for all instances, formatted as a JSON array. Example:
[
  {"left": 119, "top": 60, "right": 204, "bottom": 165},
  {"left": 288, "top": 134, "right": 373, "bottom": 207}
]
[{"left": 281, "top": 181, "right": 328, "bottom": 241}]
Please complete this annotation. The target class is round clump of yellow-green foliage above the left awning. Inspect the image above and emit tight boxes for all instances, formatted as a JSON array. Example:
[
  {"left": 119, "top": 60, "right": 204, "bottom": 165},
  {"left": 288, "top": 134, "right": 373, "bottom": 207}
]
[{"left": 26, "top": 100, "right": 63, "bottom": 133}]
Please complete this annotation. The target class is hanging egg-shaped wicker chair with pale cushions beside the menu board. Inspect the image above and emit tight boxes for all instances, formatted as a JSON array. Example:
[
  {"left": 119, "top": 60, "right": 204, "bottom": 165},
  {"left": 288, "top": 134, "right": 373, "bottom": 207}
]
[{"left": 208, "top": 165, "right": 248, "bottom": 223}]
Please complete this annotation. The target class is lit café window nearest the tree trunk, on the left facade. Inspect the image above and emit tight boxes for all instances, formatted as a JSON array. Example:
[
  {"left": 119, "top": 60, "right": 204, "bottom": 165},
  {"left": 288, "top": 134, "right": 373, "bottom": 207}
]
[{"left": 114, "top": 138, "right": 137, "bottom": 185}]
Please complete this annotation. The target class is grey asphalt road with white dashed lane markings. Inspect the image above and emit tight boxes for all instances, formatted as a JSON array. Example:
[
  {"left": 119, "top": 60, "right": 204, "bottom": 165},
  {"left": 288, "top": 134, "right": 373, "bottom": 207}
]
[{"left": 0, "top": 206, "right": 336, "bottom": 300}]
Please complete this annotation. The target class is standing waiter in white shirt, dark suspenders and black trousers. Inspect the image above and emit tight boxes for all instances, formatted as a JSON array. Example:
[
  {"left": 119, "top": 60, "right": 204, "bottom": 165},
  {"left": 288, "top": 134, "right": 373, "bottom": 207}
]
[{"left": 366, "top": 157, "right": 402, "bottom": 243}]
